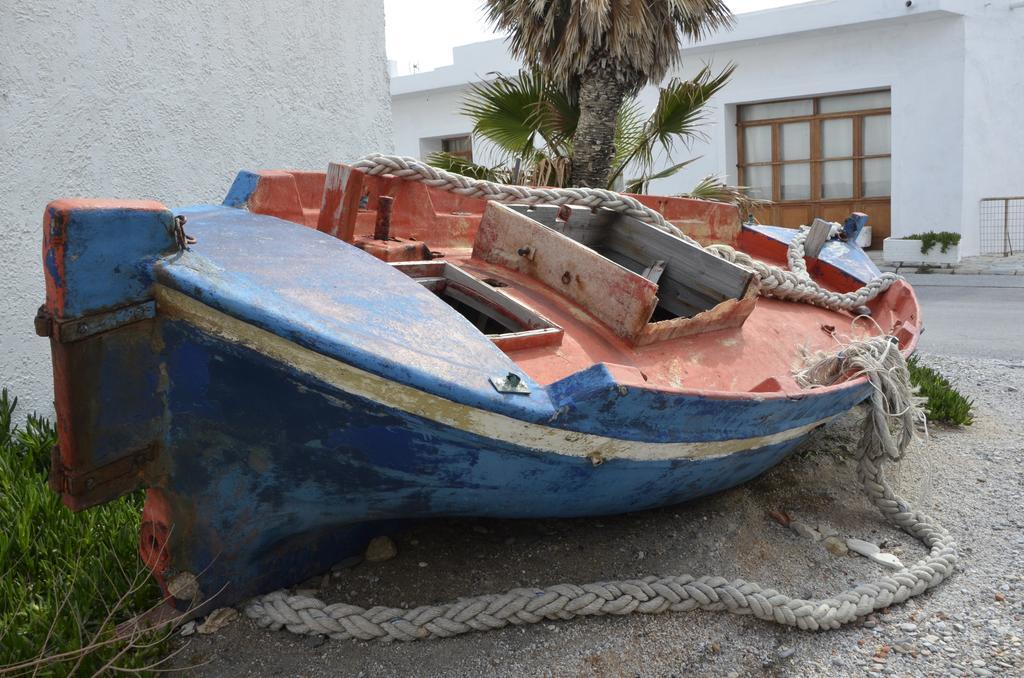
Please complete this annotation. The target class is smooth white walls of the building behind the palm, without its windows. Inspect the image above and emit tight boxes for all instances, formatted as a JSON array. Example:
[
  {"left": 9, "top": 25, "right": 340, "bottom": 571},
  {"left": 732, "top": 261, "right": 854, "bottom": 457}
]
[{"left": 392, "top": 0, "right": 1024, "bottom": 255}]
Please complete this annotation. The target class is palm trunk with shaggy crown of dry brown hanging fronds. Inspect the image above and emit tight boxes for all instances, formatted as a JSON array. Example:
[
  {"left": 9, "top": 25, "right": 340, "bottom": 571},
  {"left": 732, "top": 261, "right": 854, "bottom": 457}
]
[{"left": 484, "top": 0, "right": 732, "bottom": 186}]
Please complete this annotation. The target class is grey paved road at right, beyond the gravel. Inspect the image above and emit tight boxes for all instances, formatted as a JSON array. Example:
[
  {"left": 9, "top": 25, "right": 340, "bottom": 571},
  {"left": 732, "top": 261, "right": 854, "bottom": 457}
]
[{"left": 905, "top": 273, "right": 1024, "bottom": 362}]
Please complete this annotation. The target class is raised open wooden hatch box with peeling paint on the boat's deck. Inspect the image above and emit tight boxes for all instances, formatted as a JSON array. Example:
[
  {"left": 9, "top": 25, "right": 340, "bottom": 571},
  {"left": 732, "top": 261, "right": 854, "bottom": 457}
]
[{"left": 473, "top": 203, "right": 757, "bottom": 345}]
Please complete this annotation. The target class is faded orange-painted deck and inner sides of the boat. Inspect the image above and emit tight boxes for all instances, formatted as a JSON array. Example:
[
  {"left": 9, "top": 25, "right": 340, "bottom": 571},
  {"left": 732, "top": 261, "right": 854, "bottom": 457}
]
[{"left": 235, "top": 171, "right": 921, "bottom": 398}]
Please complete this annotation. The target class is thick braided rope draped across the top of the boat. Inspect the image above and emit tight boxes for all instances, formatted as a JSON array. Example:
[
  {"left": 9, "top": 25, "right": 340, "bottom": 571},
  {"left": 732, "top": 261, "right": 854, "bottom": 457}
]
[{"left": 352, "top": 154, "right": 900, "bottom": 310}]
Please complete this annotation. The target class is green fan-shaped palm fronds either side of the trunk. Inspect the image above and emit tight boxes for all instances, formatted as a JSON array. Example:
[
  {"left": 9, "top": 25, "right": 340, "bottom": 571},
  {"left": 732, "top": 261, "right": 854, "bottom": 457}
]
[{"left": 427, "top": 66, "right": 752, "bottom": 206}]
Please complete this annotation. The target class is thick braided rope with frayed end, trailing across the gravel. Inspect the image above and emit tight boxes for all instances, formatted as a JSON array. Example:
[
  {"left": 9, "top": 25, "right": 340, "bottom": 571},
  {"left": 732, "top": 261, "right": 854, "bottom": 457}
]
[{"left": 246, "top": 337, "right": 957, "bottom": 641}]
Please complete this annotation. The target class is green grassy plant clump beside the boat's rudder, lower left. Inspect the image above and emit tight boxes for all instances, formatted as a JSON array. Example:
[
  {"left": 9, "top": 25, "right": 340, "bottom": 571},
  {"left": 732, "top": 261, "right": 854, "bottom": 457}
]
[{"left": 0, "top": 389, "right": 166, "bottom": 676}]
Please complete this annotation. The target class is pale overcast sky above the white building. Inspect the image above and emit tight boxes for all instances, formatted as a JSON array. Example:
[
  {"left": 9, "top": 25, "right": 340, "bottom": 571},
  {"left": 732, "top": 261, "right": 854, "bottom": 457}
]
[{"left": 384, "top": 0, "right": 806, "bottom": 75}]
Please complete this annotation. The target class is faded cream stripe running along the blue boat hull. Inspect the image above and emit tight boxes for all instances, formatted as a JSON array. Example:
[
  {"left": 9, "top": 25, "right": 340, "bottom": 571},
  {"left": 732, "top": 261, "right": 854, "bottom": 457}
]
[{"left": 156, "top": 285, "right": 831, "bottom": 462}]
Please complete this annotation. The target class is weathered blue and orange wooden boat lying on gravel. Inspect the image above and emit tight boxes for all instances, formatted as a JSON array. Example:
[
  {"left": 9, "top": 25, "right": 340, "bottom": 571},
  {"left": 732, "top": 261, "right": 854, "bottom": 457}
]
[{"left": 37, "top": 161, "right": 920, "bottom": 607}]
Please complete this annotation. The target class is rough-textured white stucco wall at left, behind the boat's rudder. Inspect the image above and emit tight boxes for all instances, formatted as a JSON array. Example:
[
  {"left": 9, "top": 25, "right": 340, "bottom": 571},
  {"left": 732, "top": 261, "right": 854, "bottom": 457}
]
[{"left": 0, "top": 0, "right": 393, "bottom": 414}]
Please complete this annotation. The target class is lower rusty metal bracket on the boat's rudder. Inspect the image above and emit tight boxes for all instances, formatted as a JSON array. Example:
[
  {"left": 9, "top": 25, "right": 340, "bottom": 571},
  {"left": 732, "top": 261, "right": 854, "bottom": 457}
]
[{"left": 49, "top": 446, "right": 157, "bottom": 510}]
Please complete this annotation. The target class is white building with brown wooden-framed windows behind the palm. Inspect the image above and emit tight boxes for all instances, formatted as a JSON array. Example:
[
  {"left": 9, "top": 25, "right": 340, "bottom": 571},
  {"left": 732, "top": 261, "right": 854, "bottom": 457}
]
[{"left": 391, "top": 0, "right": 1024, "bottom": 255}]
